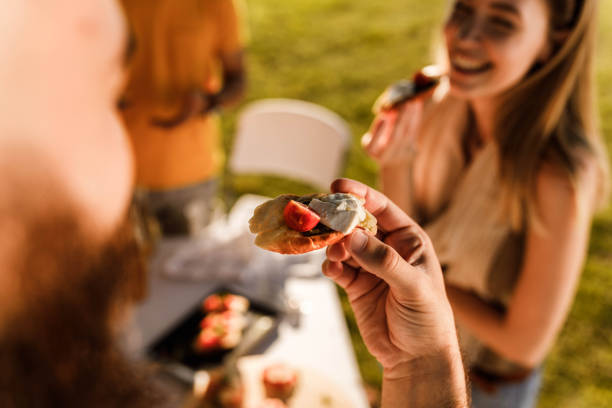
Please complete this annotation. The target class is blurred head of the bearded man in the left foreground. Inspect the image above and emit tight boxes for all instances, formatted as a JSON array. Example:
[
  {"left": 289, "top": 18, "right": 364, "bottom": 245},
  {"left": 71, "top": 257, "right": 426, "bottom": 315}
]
[{"left": 0, "top": 0, "right": 158, "bottom": 407}]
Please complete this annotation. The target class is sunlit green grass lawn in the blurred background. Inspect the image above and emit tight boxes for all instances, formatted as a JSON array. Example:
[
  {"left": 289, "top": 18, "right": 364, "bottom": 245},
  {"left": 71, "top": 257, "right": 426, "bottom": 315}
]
[{"left": 224, "top": 0, "right": 612, "bottom": 408}]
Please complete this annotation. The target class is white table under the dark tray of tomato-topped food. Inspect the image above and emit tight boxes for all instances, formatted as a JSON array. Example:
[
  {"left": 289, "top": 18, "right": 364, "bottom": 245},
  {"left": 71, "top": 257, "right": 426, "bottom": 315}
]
[{"left": 129, "top": 196, "right": 368, "bottom": 408}]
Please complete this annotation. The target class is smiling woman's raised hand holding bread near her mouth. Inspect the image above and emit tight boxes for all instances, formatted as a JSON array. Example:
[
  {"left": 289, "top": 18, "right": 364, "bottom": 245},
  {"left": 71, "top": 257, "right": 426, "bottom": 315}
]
[{"left": 361, "top": 97, "right": 429, "bottom": 166}]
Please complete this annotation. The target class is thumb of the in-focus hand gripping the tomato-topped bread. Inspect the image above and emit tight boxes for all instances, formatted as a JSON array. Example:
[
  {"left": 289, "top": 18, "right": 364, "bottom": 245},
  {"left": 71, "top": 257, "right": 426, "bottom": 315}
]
[{"left": 347, "top": 229, "right": 417, "bottom": 288}]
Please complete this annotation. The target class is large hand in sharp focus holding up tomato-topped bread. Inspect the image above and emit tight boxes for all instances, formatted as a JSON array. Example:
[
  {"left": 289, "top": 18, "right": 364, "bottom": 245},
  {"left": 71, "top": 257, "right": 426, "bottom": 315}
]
[{"left": 323, "top": 179, "right": 458, "bottom": 375}]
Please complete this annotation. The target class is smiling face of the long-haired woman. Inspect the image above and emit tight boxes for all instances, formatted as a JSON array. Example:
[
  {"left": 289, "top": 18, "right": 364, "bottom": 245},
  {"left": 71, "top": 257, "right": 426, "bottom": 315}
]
[{"left": 444, "top": 0, "right": 550, "bottom": 98}]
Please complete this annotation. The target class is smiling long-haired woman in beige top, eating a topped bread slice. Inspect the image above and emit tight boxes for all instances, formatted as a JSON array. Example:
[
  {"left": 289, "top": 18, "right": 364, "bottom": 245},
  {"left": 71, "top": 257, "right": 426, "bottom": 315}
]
[{"left": 365, "top": 0, "right": 608, "bottom": 408}]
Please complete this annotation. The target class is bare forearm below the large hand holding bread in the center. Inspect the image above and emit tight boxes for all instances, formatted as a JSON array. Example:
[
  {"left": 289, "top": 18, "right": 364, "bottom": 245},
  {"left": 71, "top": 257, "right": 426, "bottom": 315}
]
[{"left": 381, "top": 347, "right": 468, "bottom": 408}]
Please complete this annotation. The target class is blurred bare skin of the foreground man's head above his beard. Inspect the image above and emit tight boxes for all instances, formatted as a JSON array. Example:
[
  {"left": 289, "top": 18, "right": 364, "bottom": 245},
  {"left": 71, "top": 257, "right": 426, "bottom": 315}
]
[{"left": 0, "top": 0, "right": 132, "bottom": 239}]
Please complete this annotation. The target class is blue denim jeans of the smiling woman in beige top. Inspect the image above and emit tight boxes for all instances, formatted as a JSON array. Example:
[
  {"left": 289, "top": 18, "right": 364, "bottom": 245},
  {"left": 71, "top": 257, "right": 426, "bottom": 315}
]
[{"left": 472, "top": 368, "right": 542, "bottom": 408}]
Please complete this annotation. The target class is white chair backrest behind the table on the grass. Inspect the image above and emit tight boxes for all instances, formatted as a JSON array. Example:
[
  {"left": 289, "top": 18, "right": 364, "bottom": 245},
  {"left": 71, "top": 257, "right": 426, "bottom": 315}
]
[{"left": 229, "top": 99, "right": 350, "bottom": 190}]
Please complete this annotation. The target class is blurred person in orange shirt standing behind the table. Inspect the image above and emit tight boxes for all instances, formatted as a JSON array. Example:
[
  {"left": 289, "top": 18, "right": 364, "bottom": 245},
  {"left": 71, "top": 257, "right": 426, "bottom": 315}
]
[{"left": 120, "top": 0, "right": 245, "bottom": 235}]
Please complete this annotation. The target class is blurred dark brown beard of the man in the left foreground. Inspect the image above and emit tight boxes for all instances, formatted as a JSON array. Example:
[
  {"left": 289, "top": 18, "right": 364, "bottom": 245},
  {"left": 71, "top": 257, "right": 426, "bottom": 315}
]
[{"left": 0, "top": 210, "right": 163, "bottom": 407}]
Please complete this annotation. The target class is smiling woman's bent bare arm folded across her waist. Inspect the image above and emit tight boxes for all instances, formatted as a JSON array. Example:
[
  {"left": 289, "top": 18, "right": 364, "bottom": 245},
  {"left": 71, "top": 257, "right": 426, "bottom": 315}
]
[{"left": 447, "top": 162, "right": 596, "bottom": 367}]
